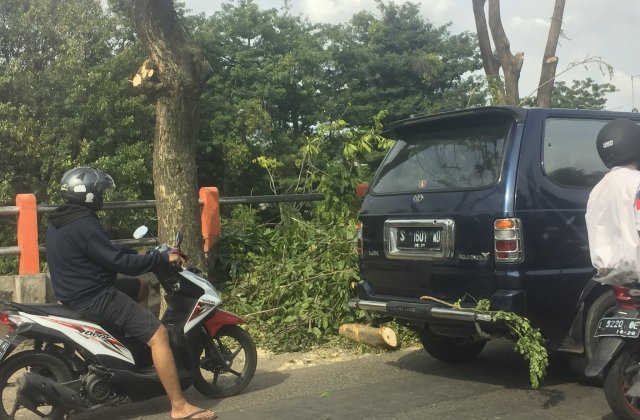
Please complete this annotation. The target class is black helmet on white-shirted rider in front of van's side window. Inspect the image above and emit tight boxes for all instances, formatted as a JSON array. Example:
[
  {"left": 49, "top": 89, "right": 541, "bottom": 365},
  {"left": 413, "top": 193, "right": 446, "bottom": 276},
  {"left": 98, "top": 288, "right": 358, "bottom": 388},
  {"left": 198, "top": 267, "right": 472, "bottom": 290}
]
[{"left": 596, "top": 118, "right": 640, "bottom": 168}]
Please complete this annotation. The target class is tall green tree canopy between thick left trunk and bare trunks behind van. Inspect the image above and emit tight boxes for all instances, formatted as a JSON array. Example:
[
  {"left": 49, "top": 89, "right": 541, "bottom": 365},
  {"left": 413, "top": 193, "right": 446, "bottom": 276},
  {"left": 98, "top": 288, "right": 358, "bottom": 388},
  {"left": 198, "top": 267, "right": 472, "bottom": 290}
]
[{"left": 189, "top": 0, "right": 480, "bottom": 195}]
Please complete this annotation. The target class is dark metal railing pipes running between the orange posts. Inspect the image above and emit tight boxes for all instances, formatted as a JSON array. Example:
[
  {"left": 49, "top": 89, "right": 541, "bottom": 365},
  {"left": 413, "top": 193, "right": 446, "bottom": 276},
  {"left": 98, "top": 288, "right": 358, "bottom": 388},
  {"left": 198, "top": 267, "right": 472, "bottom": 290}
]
[{"left": 0, "top": 193, "right": 324, "bottom": 257}]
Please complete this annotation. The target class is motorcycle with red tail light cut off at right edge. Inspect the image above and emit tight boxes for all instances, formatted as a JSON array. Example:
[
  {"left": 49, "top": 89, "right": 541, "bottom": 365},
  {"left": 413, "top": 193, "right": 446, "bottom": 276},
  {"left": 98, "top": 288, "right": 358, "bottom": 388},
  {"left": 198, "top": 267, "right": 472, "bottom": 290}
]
[{"left": 585, "top": 279, "right": 640, "bottom": 420}]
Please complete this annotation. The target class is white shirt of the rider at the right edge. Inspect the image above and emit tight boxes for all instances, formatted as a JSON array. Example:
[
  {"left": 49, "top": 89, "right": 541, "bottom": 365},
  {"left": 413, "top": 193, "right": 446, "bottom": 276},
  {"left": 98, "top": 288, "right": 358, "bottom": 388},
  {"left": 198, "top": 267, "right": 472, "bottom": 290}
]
[{"left": 585, "top": 167, "right": 640, "bottom": 280}]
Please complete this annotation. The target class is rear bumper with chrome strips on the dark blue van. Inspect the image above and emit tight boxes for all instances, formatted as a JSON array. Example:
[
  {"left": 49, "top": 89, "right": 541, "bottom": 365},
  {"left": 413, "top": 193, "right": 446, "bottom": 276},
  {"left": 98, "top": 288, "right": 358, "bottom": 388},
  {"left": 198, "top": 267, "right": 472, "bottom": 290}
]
[{"left": 349, "top": 298, "right": 493, "bottom": 322}]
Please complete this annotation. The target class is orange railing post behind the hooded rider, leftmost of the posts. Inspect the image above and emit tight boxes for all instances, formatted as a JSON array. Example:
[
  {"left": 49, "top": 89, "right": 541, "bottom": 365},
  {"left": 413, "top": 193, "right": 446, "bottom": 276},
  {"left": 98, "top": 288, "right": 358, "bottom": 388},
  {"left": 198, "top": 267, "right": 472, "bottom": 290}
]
[{"left": 16, "top": 194, "right": 40, "bottom": 275}]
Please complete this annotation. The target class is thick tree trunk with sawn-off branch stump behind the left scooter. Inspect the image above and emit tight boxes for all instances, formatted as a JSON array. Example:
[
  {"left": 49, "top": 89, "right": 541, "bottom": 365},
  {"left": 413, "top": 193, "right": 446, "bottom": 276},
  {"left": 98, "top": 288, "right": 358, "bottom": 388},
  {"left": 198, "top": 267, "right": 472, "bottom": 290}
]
[{"left": 129, "top": 0, "right": 211, "bottom": 266}]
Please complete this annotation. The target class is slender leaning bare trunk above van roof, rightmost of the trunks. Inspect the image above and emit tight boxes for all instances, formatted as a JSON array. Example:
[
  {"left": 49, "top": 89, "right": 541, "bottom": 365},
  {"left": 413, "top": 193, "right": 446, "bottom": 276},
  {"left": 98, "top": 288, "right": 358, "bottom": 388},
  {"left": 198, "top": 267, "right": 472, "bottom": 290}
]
[{"left": 536, "top": 0, "right": 565, "bottom": 108}]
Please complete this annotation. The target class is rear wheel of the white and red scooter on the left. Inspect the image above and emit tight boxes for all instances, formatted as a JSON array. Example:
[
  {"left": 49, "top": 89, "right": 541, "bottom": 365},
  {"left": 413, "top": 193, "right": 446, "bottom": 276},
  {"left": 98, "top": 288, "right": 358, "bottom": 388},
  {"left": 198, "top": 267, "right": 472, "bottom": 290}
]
[{"left": 0, "top": 350, "right": 73, "bottom": 420}]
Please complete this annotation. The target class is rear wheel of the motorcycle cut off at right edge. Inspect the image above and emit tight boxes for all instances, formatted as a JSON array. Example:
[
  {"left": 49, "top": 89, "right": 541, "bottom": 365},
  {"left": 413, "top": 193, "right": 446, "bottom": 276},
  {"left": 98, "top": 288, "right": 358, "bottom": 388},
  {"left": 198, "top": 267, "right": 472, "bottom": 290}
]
[{"left": 604, "top": 345, "right": 640, "bottom": 420}]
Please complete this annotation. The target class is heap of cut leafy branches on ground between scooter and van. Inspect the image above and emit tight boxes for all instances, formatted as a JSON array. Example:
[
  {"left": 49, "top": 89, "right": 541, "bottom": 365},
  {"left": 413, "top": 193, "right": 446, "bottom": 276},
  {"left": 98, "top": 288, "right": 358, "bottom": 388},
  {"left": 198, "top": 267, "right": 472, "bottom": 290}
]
[{"left": 225, "top": 208, "right": 357, "bottom": 351}]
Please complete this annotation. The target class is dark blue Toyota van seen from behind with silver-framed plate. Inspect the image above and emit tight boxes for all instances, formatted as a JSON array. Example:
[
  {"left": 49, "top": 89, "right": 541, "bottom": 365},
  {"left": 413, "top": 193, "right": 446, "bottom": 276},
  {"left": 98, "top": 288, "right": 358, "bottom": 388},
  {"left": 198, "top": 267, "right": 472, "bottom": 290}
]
[{"left": 349, "top": 106, "right": 640, "bottom": 373}]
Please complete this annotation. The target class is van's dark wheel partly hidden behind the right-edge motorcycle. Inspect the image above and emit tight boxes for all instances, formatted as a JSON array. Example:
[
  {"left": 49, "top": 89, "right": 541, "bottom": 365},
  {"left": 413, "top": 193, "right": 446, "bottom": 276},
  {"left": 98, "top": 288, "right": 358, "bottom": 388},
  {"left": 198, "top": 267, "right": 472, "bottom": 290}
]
[{"left": 569, "top": 291, "right": 617, "bottom": 385}]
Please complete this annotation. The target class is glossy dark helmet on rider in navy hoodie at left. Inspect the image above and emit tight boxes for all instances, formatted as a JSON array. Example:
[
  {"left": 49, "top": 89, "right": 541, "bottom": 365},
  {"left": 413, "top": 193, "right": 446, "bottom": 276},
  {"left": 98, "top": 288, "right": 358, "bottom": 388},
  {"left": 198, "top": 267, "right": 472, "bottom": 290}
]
[{"left": 60, "top": 167, "right": 116, "bottom": 211}]
